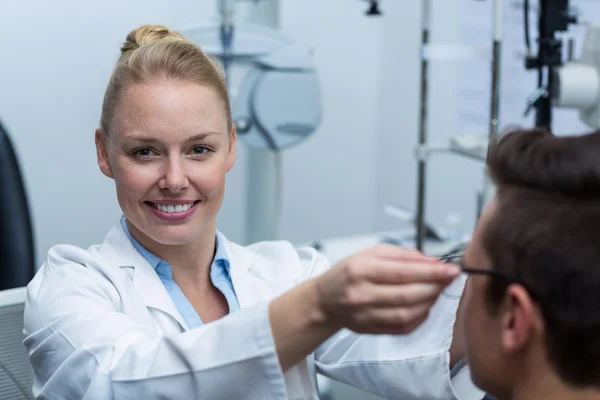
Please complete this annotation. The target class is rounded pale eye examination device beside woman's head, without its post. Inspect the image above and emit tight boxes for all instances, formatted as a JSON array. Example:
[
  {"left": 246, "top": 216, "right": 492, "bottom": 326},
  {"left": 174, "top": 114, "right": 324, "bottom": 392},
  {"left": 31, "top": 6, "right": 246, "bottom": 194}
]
[{"left": 183, "top": 0, "right": 322, "bottom": 151}]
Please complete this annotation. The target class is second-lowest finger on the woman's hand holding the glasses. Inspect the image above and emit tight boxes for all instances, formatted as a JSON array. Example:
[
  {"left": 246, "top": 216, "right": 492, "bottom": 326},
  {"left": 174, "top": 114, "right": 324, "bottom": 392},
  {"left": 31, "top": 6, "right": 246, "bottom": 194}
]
[{"left": 348, "top": 282, "right": 446, "bottom": 308}]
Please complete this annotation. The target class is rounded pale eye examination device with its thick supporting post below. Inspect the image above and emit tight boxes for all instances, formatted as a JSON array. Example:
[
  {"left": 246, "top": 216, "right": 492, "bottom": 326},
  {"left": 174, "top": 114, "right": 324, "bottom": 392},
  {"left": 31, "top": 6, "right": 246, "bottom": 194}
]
[{"left": 182, "top": 0, "right": 322, "bottom": 243}]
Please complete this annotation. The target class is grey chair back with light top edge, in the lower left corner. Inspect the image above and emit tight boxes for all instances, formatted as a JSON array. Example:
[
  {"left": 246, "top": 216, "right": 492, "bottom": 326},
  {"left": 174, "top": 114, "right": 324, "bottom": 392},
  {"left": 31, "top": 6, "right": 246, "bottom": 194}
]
[{"left": 0, "top": 287, "right": 33, "bottom": 400}]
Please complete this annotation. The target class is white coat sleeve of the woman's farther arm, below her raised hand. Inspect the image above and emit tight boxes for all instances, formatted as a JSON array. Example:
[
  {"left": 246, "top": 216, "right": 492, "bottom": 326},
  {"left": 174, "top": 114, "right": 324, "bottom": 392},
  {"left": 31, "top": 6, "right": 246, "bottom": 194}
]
[{"left": 304, "top": 250, "right": 464, "bottom": 400}]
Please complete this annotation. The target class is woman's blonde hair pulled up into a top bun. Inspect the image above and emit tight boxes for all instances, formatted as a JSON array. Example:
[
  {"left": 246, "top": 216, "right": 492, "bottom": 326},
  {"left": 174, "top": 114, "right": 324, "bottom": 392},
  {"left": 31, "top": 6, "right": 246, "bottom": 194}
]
[{"left": 100, "top": 25, "right": 232, "bottom": 133}]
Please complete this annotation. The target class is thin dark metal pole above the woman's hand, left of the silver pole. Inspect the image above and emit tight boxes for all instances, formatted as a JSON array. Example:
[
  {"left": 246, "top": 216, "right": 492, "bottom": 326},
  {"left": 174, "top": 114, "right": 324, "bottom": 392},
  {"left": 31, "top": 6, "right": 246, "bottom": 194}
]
[{"left": 415, "top": 0, "right": 431, "bottom": 251}]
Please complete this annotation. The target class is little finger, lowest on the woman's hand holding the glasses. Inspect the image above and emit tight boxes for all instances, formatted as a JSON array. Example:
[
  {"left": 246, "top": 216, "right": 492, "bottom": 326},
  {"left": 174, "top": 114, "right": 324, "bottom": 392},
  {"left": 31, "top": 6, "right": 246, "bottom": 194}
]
[{"left": 356, "top": 303, "right": 433, "bottom": 333}]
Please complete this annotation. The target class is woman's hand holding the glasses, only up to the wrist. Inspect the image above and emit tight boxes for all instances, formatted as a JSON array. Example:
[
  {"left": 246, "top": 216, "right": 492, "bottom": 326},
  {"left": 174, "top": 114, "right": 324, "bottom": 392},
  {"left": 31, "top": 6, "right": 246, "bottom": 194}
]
[{"left": 315, "top": 245, "right": 460, "bottom": 334}]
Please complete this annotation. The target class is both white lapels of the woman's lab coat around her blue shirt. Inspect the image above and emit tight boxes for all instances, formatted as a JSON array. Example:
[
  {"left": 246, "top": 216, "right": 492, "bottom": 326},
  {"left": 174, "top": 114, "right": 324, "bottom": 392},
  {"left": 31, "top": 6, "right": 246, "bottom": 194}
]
[{"left": 98, "top": 221, "right": 257, "bottom": 330}]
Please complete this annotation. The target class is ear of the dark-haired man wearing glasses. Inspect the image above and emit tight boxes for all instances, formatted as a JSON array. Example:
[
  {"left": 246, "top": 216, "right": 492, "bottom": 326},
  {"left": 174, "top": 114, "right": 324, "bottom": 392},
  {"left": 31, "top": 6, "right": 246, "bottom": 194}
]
[{"left": 502, "top": 284, "right": 537, "bottom": 353}]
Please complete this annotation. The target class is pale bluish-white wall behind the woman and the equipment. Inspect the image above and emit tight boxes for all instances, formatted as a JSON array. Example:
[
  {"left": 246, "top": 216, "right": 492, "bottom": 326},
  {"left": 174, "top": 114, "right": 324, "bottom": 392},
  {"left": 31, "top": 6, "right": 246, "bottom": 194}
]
[{"left": 0, "top": 0, "right": 481, "bottom": 268}]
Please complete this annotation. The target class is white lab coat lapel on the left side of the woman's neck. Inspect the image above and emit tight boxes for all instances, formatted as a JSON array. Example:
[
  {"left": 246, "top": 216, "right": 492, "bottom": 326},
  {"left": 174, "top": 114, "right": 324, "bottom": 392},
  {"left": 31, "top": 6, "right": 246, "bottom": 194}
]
[{"left": 100, "top": 223, "right": 188, "bottom": 330}]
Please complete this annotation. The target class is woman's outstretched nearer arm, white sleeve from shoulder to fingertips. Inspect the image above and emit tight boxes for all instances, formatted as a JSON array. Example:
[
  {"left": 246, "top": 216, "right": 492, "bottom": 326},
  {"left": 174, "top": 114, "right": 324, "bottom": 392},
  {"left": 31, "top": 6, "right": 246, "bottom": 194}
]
[{"left": 24, "top": 247, "right": 456, "bottom": 399}]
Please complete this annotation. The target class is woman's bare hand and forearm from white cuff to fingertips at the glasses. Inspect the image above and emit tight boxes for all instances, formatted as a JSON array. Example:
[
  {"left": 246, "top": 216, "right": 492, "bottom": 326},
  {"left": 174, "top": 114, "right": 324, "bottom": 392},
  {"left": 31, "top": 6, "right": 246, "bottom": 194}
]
[{"left": 269, "top": 245, "right": 460, "bottom": 371}]
